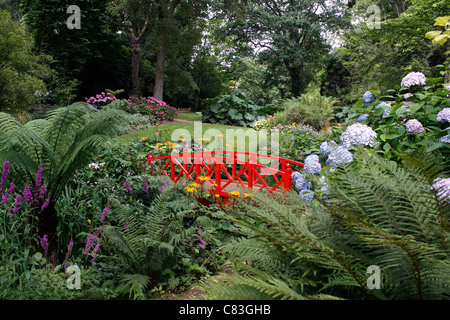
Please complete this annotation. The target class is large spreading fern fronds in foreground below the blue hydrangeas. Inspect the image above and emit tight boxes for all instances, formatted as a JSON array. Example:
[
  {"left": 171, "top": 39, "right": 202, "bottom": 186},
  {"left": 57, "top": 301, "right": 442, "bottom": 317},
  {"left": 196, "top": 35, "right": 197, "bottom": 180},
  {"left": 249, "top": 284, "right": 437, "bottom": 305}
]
[{"left": 201, "top": 151, "right": 450, "bottom": 299}]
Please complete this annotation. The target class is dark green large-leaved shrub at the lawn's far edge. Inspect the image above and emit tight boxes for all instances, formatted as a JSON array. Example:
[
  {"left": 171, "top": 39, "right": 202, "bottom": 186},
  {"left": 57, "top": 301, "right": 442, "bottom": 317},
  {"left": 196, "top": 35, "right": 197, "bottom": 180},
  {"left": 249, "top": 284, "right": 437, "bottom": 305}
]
[{"left": 203, "top": 91, "right": 260, "bottom": 127}]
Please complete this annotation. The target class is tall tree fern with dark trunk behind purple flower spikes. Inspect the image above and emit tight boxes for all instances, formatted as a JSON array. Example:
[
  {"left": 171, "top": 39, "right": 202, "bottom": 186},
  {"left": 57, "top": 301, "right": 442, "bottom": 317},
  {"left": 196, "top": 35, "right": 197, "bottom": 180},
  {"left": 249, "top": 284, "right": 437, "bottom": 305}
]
[{"left": 0, "top": 102, "right": 144, "bottom": 260}]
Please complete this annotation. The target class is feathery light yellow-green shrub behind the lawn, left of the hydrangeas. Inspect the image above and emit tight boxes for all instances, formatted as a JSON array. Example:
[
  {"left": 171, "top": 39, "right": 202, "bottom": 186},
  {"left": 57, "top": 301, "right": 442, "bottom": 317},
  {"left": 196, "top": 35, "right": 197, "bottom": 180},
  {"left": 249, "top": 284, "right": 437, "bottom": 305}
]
[{"left": 275, "top": 91, "right": 335, "bottom": 130}]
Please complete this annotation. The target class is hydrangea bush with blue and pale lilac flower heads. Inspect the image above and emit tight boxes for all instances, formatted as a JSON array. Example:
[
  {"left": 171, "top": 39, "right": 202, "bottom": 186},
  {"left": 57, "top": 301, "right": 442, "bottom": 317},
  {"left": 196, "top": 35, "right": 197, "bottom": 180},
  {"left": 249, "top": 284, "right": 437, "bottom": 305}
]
[{"left": 292, "top": 63, "right": 450, "bottom": 202}]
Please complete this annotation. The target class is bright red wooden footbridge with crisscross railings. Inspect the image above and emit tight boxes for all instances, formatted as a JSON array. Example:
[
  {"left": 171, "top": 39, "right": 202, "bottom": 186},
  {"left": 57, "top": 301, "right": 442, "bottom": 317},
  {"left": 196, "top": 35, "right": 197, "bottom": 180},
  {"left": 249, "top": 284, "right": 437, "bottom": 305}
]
[{"left": 147, "top": 149, "right": 304, "bottom": 198}]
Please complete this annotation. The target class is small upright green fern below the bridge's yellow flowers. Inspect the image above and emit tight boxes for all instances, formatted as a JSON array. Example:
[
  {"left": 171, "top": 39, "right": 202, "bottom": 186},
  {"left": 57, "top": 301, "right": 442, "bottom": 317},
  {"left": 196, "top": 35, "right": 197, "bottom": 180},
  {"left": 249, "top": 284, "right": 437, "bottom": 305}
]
[{"left": 104, "top": 187, "right": 197, "bottom": 298}]
